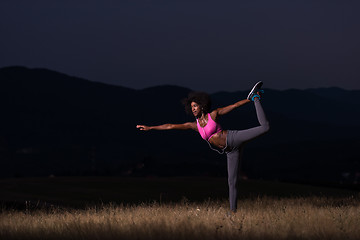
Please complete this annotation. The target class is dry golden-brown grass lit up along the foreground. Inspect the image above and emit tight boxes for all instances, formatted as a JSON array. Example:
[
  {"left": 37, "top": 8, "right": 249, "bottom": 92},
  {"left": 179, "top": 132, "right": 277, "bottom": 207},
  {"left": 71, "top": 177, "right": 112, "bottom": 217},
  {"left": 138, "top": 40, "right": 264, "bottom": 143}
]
[{"left": 0, "top": 197, "right": 360, "bottom": 239}]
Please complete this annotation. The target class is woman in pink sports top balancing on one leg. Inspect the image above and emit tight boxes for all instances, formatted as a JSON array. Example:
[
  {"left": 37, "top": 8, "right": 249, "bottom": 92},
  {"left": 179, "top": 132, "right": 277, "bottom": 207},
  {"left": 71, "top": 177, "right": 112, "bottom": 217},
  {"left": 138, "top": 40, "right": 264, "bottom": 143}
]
[{"left": 136, "top": 81, "right": 269, "bottom": 212}]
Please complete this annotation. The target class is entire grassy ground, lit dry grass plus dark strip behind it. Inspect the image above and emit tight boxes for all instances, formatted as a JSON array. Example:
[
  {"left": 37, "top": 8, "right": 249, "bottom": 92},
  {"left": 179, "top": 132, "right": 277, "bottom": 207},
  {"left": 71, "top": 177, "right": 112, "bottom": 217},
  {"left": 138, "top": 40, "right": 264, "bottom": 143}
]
[{"left": 0, "top": 178, "right": 360, "bottom": 240}]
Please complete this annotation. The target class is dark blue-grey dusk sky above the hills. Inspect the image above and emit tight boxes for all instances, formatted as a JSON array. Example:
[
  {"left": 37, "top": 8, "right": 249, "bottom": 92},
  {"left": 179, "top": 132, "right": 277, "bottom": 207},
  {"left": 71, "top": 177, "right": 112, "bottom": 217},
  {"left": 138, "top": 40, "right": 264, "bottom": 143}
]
[{"left": 0, "top": 0, "right": 360, "bottom": 92}]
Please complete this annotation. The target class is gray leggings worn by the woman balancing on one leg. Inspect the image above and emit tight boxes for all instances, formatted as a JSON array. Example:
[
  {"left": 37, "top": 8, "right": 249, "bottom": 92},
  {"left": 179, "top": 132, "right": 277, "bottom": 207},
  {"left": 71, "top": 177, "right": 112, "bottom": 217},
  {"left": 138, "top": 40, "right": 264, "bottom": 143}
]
[{"left": 225, "top": 99, "right": 270, "bottom": 212}]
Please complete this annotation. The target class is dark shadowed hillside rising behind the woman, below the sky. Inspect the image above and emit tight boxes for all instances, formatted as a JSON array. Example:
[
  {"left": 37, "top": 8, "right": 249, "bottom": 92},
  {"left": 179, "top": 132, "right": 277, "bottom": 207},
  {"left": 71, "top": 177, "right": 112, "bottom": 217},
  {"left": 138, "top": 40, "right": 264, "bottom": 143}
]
[{"left": 0, "top": 67, "right": 360, "bottom": 181}]
